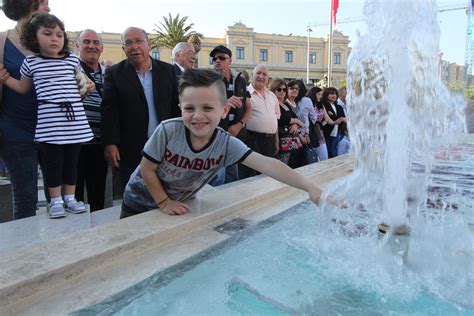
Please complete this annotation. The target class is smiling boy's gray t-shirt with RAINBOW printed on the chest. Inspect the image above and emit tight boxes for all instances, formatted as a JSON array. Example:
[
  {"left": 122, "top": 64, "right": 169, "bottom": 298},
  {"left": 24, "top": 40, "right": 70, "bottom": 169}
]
[{"left": 123, "top": 118, "right": 252, "bottom": 212}]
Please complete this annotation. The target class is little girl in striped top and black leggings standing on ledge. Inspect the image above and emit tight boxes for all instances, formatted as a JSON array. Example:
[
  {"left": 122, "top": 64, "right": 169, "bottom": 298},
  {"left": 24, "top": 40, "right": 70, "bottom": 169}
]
[{"left": 0, "top": 14, "right": 93, "bottom": 218}]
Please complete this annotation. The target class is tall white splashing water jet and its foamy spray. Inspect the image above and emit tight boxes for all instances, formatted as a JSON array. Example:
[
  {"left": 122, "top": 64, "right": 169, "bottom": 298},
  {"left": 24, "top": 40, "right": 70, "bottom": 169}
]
[{"left": 320, "top": 0, "right": 474, "bottom": 308}]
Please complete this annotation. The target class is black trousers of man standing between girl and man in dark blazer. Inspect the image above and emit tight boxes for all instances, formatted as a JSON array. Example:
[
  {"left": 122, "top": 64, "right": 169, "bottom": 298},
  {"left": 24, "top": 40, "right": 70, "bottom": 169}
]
[{"left": 76, "top": 144, "right": 107, "bottom": 212}]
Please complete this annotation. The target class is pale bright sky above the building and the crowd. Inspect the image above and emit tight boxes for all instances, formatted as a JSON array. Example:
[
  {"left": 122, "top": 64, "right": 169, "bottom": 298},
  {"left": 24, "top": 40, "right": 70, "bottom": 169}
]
[{"left": 0, "top": 0, "right": 468, "bottom": 65}]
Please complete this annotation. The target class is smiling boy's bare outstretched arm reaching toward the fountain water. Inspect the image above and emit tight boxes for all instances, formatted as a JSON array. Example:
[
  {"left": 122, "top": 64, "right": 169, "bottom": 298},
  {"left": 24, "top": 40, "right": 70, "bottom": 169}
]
[{"left": 242, "top": 152, "right": 322, "bottom": 204}]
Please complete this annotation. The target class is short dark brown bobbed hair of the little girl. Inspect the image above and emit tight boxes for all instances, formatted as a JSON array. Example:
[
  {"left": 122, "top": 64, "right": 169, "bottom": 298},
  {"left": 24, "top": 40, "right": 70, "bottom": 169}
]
[{"left": 20, "top": 13, "right": 69, "bottom": 54}]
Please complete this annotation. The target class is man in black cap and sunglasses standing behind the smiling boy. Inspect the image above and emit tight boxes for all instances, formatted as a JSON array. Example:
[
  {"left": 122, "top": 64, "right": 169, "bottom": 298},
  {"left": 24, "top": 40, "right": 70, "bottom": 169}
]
[{"left": 209, "top": 45, "right": 252, "bottom": 186}]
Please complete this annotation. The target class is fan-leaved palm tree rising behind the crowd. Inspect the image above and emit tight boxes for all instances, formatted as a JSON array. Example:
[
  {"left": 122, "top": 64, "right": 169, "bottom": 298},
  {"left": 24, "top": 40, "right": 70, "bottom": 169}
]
[{"left": 152, "top": 13, "right": 202, "bottom": 49}]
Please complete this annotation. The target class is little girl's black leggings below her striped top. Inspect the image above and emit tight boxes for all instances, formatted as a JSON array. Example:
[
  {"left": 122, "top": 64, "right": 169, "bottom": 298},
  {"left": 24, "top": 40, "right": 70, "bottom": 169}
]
[{"left": 39, "top": 143, "right": 81, "bottom": 188}]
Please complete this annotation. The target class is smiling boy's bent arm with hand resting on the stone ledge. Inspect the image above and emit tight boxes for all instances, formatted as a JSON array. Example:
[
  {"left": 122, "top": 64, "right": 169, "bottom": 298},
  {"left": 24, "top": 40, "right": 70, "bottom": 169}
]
[{"left": 140, "top": 157, "right": 189, "bottom": 215}]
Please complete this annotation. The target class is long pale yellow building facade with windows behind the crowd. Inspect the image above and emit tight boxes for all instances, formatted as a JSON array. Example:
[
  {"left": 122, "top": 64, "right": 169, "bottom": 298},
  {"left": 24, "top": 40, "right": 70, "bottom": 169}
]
[{"left": 69, "top": 22, "right": 350, "bottom": 86}]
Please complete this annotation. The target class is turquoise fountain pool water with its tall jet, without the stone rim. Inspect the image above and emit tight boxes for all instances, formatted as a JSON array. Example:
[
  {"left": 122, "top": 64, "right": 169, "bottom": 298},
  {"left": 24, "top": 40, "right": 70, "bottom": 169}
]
[{"left": 71, "top": 0, "right": 474, "bottom": 315}]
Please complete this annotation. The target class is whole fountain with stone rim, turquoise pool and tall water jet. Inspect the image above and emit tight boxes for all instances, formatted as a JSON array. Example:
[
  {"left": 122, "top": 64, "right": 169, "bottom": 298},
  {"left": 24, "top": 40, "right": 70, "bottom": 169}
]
[{"left": 0, "top": 0, "right": 474, "bottom": 315}]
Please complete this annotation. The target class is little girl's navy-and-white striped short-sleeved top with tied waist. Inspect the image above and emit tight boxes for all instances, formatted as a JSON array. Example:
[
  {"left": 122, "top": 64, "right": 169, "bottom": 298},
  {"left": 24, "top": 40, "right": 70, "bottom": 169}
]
[{"left": 20, "top": 54, "right": 93, "bottom": 145}]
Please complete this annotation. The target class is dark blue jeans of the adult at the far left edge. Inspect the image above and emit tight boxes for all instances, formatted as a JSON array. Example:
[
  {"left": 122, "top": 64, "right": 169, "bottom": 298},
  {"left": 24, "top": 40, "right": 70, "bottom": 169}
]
[{"left": 2, "top": 142, "right": 38, "bottom": 220}]
